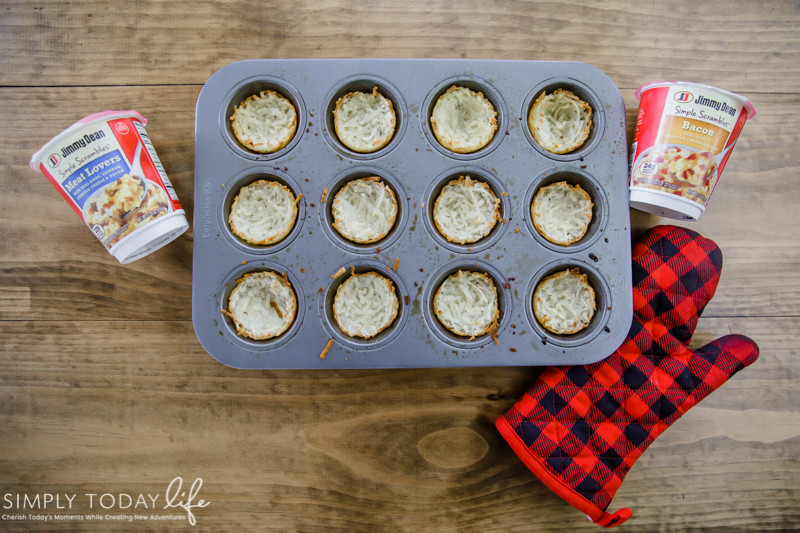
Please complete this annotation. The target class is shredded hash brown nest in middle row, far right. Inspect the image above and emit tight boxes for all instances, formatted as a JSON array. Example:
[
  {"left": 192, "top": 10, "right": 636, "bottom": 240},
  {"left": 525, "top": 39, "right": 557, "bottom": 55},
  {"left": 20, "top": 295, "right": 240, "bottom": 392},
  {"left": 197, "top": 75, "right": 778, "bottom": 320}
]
[{"left": 531, "top": 181, "right": 594, "bottom": 246}]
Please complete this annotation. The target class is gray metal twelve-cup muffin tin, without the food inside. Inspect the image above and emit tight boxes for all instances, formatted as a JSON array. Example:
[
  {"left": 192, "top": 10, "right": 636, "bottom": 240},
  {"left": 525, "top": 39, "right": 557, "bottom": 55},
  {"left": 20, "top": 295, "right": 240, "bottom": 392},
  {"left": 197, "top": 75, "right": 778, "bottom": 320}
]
[{"left": 192, "top": 59, "right": 632, "bottom": 369}]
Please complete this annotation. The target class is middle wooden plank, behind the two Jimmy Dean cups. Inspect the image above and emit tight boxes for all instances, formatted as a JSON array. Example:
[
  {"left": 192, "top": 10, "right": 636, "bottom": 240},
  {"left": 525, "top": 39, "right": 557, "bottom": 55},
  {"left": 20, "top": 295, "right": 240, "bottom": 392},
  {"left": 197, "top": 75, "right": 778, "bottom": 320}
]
[{"left": 0, "top": 86, "right": 800, "bottom": 320}]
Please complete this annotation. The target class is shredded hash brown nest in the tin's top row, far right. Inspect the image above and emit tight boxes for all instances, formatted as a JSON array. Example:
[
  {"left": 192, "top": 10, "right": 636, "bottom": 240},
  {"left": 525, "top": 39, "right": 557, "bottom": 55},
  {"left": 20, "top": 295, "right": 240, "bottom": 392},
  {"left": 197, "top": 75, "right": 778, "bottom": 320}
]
[{"left": 528, "top": 89, "right": 592, "bottom": 154}]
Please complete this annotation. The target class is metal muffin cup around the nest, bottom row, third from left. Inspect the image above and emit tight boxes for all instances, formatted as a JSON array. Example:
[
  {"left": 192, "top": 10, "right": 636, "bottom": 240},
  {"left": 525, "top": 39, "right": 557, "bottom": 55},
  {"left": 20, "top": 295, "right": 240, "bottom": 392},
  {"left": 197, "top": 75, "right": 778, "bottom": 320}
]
[{"left": 422, "top": 259, "right": 513, "bottom": 349}]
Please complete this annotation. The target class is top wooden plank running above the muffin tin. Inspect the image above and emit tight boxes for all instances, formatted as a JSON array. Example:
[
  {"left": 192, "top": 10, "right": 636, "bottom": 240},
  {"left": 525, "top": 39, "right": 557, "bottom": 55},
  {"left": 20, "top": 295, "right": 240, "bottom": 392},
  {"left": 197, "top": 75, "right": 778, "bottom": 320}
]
[{"left": 0, "top": 0, "right": 800, "bottom": 92}]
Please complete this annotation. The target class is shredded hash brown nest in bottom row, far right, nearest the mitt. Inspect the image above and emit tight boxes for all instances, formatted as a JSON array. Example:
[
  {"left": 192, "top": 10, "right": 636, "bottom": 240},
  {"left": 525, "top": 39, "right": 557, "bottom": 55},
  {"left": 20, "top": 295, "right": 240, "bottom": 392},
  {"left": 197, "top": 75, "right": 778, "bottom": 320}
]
[{"left": 533, "top": 268, "right": 597, "bottom": 335}]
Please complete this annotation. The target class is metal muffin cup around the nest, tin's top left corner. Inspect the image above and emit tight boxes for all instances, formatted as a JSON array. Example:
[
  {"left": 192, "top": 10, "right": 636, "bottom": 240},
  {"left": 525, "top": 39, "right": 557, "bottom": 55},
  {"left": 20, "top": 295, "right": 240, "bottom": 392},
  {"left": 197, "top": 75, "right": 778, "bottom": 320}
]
[{"left": 219, "top": 76, "right": 308, "bottom": 161}]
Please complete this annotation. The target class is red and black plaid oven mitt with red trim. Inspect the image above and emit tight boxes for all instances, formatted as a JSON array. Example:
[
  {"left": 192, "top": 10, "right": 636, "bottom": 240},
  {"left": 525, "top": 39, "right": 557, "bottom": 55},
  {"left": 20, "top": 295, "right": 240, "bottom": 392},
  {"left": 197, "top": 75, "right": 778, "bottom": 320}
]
[{"left": 497, "top": 226, "right": 758, "bottom": 527}]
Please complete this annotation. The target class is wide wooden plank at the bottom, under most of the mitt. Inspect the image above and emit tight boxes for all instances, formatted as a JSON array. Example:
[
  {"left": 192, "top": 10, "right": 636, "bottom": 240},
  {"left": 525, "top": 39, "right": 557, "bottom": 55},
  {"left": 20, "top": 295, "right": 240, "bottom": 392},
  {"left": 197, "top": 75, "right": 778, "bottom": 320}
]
[{"left": 0, "top": 318, "right": 800, "bottom": 532}]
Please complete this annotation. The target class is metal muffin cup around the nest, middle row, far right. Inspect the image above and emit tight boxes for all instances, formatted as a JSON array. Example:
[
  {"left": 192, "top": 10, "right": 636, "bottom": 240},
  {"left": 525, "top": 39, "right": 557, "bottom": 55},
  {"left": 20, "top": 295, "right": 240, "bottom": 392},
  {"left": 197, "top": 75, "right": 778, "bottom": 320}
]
[{"left": 523, "top": 167, "right": 608, "bottom": 254}]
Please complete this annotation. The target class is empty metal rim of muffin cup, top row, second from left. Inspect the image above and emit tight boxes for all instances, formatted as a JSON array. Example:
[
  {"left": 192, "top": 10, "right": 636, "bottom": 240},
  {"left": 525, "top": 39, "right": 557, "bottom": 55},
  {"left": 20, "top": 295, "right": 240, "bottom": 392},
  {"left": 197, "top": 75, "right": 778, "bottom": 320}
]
[{"left": 322, "top": 75, "right": 408, "bottom": 161}]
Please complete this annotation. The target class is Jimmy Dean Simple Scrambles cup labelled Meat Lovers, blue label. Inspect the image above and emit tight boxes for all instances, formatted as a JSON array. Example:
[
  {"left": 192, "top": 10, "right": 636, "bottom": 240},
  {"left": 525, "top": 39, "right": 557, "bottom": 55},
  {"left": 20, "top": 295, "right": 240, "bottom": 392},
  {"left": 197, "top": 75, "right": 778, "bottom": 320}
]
[{"left": 30, "top": 111, "right": 189, "bottom": 264}]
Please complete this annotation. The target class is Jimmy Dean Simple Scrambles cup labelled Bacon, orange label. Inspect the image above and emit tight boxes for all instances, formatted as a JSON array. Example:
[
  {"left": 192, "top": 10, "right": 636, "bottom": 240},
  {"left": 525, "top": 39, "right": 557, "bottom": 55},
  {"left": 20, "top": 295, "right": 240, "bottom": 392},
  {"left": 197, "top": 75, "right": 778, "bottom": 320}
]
[{"left": 630, "top": 81, "right": 758, "bottom": 220}]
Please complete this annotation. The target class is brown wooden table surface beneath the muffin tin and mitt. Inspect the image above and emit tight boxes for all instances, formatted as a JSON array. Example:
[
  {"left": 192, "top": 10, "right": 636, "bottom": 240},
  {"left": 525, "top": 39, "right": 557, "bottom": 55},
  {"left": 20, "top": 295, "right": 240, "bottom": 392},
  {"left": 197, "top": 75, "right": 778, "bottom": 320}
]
[{"left": 0, "top": 0, "right": 800, "bottom": 532}]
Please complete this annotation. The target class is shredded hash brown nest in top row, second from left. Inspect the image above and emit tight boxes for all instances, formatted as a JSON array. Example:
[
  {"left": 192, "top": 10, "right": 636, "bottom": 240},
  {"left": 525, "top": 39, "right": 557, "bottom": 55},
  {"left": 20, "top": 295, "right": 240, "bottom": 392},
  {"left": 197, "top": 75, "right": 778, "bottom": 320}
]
[{"left": 333, "top": 87, "right": 397, "bottom": 153}]
